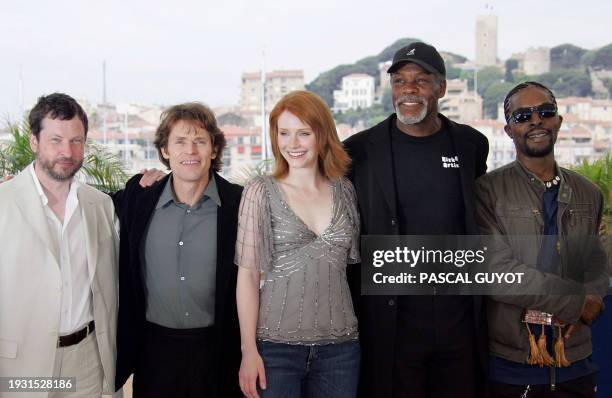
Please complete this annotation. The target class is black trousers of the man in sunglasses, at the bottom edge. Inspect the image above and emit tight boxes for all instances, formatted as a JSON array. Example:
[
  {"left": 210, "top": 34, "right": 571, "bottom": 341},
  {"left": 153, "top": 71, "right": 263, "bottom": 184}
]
[{"left": 490, "top": 373, "right": 597, "bottom": 398}]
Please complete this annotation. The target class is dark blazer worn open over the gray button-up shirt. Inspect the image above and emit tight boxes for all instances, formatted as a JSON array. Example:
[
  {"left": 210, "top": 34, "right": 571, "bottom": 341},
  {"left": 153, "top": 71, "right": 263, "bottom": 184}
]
[{"left": 113, "top": 173, "right": 242, "bottom": 397}]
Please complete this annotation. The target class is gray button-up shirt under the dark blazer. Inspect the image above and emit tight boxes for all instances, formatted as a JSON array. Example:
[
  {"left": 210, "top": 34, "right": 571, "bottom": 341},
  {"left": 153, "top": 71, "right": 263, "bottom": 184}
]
[{"left": 141, "top": 174, "right": 221, "bottom": 329}]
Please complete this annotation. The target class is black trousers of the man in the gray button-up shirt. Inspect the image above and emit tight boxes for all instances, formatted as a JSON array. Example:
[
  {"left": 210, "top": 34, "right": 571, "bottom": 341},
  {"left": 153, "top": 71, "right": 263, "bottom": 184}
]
[{"left": 133, "top": 322, "right": 219, "bottom": 398}]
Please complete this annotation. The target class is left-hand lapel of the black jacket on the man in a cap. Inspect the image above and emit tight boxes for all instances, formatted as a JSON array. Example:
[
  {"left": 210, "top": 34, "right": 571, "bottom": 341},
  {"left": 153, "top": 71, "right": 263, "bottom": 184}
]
[{"left": 367, "top": 116, "right": 397, "bottom": 213}]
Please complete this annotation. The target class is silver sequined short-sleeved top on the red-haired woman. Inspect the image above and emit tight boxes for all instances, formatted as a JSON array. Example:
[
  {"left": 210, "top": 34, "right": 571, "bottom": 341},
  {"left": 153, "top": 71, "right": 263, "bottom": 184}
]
[{"left": 235, "top": 176, "right": 360, "bottom": 344}]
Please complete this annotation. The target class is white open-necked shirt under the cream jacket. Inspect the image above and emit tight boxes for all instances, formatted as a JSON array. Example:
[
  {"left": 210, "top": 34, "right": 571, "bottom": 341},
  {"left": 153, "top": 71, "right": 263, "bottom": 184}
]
[{"left": 29, "top": 163, "right": 93, "bottom": 336}]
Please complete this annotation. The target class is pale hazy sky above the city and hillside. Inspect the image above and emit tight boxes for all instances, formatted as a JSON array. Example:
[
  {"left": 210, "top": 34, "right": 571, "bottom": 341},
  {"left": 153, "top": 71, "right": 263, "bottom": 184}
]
[{"left": 0, "top": 0, "right": 612, "bottom": 120}]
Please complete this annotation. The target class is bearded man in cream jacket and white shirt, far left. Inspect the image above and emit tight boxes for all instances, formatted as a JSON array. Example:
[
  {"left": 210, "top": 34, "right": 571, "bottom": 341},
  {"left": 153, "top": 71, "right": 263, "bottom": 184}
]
[{"left": 0, "top": 93, "right": 119, "bottom": 397}]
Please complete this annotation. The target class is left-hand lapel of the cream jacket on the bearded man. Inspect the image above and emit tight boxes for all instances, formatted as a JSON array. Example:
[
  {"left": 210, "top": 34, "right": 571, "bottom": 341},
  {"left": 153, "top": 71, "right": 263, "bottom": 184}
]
[{"left": 15, "top": 167, "right": 59, "bottom": 267}]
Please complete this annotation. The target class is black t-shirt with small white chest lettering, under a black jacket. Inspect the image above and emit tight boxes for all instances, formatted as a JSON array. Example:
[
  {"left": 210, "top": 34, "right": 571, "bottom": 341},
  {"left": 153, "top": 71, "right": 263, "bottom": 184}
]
[{"left": 391, "top": 119, "right": 473, "bottom": 336}]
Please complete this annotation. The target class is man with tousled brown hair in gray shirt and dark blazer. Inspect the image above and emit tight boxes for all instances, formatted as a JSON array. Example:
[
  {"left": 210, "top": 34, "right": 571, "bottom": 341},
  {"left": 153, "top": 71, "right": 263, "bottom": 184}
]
[{"left": 113, "top": 103, "right": 242, "bottom": 398}]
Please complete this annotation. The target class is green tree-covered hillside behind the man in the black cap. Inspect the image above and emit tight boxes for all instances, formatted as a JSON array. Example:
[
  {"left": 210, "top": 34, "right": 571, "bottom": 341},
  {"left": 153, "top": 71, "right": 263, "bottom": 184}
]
[{"left": 306, "top": 38, "right": 612, "bottom": 125}]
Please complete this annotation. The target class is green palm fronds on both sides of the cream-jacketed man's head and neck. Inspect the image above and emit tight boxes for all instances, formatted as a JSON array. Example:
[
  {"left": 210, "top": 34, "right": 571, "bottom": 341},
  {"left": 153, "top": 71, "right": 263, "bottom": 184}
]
[{"left": 0, "top": 122, "right": 128, "bottom": 192}]
